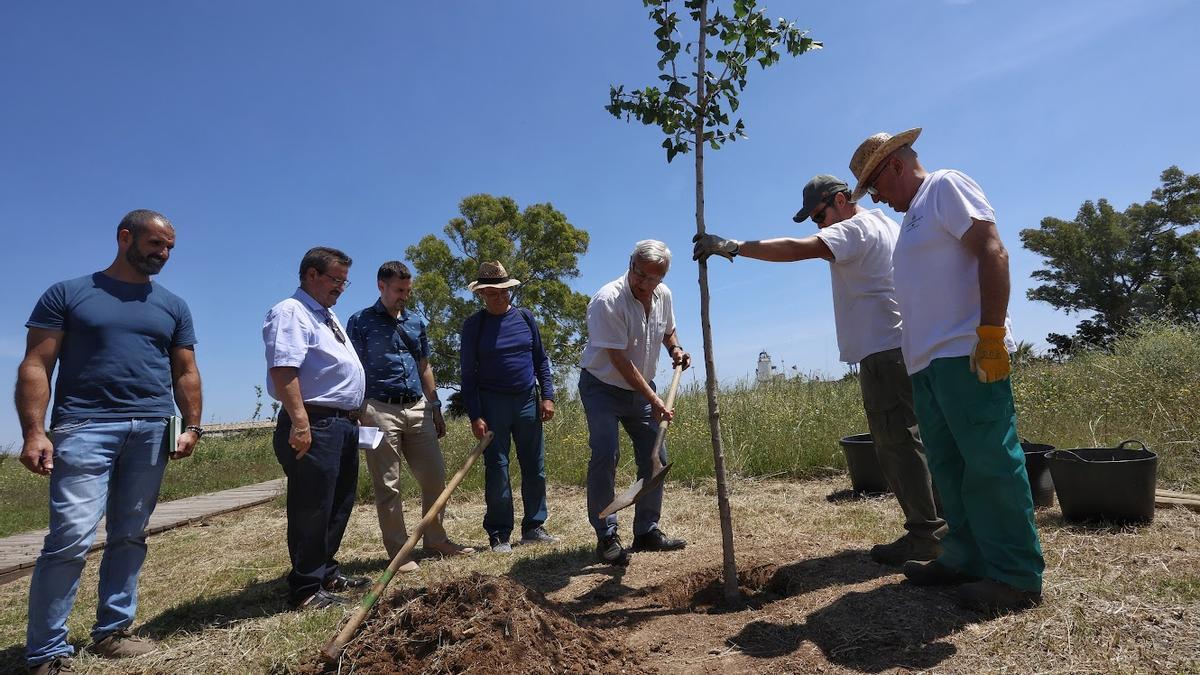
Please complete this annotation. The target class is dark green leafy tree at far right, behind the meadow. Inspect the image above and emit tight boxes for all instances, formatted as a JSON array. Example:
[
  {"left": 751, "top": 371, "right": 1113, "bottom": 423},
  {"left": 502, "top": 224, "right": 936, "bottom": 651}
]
[{"left": 1021, "top": 167, "right": 1200, "bottom": 357}]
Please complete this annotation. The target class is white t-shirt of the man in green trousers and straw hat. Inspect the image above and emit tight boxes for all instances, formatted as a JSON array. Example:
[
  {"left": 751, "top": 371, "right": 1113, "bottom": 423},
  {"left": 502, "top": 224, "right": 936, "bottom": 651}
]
[{"left": 892, "top": 164, "right": 1016, "bottom": 375}]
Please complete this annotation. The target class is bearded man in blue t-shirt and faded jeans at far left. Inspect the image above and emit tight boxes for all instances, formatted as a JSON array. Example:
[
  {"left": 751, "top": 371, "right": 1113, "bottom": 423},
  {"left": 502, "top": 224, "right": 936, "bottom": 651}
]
[{"left": 16, "top": 209, "right": 204, "bottom": 674}]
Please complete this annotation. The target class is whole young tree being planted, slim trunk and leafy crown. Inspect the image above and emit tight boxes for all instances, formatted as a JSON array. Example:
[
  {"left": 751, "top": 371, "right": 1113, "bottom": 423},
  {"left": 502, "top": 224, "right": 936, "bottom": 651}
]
[{"left": 605, "top": 0, "right": 821, "bottom": 601}]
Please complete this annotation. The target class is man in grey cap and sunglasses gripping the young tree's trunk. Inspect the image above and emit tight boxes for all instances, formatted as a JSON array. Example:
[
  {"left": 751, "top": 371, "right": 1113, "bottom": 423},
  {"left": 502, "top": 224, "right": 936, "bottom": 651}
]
[{"left": 692, "top": 174, "right": 946, "bottom": 566}]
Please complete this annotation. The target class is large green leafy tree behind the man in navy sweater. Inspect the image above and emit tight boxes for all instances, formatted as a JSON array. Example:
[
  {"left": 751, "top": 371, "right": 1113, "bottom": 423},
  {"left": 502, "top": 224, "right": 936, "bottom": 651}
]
[{"left": 404, "top": 195, "right": 588, "bottom": 389}]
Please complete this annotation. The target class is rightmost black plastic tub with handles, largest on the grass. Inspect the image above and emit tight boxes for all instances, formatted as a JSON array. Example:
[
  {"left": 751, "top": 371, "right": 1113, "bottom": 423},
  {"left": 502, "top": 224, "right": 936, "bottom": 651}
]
[{"left": 1046, "top": 441, "right": 1158, "bottom": 525}]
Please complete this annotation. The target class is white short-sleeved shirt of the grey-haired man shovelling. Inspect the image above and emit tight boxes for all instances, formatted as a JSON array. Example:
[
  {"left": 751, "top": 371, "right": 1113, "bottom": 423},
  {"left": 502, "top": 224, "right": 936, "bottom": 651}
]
[{"left": 580, "top": 274, "right": 674, "bottom": 390}]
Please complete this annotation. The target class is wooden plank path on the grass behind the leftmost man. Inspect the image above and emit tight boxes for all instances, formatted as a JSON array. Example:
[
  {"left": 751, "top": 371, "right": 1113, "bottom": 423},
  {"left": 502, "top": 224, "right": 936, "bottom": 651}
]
[{"left": 0, "top": 478, "right": 284, "bottom": 584}]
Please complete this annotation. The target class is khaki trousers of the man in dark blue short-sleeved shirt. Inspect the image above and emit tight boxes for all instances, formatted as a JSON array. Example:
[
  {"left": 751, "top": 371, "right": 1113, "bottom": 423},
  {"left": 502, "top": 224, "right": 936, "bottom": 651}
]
[{"left": 361, "top": 399, "right": 446, "bottom": 557}]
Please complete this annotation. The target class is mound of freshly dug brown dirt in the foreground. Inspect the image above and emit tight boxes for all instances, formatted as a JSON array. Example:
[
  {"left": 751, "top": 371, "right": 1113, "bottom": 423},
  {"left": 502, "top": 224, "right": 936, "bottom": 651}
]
[{"left": 304, "top": 573, "right": 653, "bottom": 674}]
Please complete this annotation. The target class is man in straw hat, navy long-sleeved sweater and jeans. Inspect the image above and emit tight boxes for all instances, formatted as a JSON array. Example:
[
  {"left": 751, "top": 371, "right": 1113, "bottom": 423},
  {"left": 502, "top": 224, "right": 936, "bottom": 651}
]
[{"left": 458, "top": 262, "right": 558, "bottom": 552}]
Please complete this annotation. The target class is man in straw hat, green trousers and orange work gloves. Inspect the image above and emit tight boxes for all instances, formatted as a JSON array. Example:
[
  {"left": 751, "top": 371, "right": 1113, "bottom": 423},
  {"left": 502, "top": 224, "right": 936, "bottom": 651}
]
[{"left": 850, "top": 129, "right": 1045, "bottom": 613}]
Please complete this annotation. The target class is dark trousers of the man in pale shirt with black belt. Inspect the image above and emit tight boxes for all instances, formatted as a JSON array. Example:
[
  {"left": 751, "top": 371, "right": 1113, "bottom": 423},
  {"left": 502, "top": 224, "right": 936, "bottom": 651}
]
[{"left": 274, "top": 411, "right": 359, "bottom": 602}]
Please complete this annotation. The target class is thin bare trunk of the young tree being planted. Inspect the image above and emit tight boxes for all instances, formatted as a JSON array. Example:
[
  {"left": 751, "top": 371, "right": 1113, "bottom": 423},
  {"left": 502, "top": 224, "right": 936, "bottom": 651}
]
[{"left": 695, "top": 0, "right": 738, "bottom": 602}]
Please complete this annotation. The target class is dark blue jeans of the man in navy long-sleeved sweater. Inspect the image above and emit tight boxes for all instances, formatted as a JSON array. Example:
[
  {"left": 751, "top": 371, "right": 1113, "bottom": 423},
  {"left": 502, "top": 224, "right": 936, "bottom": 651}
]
[{"left": 479, "top": 387, "right": 546, "bottom": 542}]
